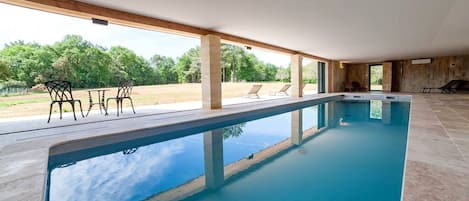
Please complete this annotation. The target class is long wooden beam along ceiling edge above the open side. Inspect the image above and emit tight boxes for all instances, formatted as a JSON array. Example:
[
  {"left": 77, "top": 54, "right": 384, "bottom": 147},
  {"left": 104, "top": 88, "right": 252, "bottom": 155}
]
[{"left": 0, "top": 0, "right": 329, "bottom": 62}]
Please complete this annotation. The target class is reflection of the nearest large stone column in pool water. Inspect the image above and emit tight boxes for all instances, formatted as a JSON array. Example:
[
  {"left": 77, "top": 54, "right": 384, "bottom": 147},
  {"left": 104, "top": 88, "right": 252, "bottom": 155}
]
[{"left": 204, "top": 129, "right": 224, "bottom": 189}]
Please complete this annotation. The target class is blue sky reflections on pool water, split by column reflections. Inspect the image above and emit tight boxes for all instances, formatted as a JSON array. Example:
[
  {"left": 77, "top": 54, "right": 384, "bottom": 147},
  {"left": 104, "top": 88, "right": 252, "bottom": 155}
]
[{"left": 48, "top": 107, "right": 317, "bottom": 200}]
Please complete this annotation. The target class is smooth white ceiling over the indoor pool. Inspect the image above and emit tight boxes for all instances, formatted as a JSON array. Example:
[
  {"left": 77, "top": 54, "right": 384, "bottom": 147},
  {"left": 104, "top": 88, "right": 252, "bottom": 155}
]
[{"left": 81, "top": 0, "right": 469, "bottom": 62}]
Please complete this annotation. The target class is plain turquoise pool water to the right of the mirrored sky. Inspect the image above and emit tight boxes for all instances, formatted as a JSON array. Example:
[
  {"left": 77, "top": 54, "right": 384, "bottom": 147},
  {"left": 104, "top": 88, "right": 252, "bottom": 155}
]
[{"left": 185, "top": 102, "right": 409, "bottom": 201}]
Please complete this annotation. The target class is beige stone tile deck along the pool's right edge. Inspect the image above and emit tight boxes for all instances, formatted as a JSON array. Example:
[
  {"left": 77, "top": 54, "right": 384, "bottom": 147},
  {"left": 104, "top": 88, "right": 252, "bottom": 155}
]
[{"left": 404, "top": 94, "right": 469, "bottom": 201}]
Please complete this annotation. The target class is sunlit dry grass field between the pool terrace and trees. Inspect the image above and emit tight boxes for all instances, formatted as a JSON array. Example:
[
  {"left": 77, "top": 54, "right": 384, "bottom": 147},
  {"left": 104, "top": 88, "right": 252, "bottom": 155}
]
[{"left": 0, "top": 82, "right": 316, "bottom": 118}]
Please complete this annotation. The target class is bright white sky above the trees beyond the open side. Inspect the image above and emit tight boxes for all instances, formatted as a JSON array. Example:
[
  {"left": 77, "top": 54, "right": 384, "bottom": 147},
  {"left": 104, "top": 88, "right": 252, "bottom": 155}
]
[{"left": 0, "top": 3, "right": 290, "bottom": 67}]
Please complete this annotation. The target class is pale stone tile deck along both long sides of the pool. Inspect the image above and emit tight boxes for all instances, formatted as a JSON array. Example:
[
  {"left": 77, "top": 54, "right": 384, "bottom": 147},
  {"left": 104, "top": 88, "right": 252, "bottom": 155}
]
[{"left": 0, "top": 94, "right": 469, "bottom": 201}]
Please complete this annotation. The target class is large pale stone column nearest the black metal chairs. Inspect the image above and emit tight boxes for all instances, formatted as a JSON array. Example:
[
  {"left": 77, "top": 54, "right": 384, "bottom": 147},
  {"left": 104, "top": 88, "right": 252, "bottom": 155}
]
[{"left": 200, "top": 35, "right": 222, "bottom": 110}]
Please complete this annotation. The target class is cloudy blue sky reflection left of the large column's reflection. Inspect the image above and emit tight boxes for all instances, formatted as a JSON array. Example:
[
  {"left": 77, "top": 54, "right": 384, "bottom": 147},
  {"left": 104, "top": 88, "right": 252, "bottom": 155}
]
[{"left": 50, "top": 135, "right": 203, "bottom": 200}]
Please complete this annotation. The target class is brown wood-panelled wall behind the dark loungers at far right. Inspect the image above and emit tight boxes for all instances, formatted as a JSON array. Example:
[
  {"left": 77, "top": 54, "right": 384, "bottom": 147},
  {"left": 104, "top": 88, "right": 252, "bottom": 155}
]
[{"left": 392, "top": 55, "right": 469, "bottom": 92}]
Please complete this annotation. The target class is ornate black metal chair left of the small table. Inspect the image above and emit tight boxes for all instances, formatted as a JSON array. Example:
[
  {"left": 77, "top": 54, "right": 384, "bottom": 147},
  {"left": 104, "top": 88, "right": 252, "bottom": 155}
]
[{"left": 44, "top": 80, "right": 85, "bottom": 123}]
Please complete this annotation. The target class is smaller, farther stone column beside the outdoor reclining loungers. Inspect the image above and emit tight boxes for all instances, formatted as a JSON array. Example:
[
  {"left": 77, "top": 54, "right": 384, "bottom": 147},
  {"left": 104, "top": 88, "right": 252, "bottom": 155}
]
[{"left": 290, "top": 54, "right": 303, "bottom": 98}]
